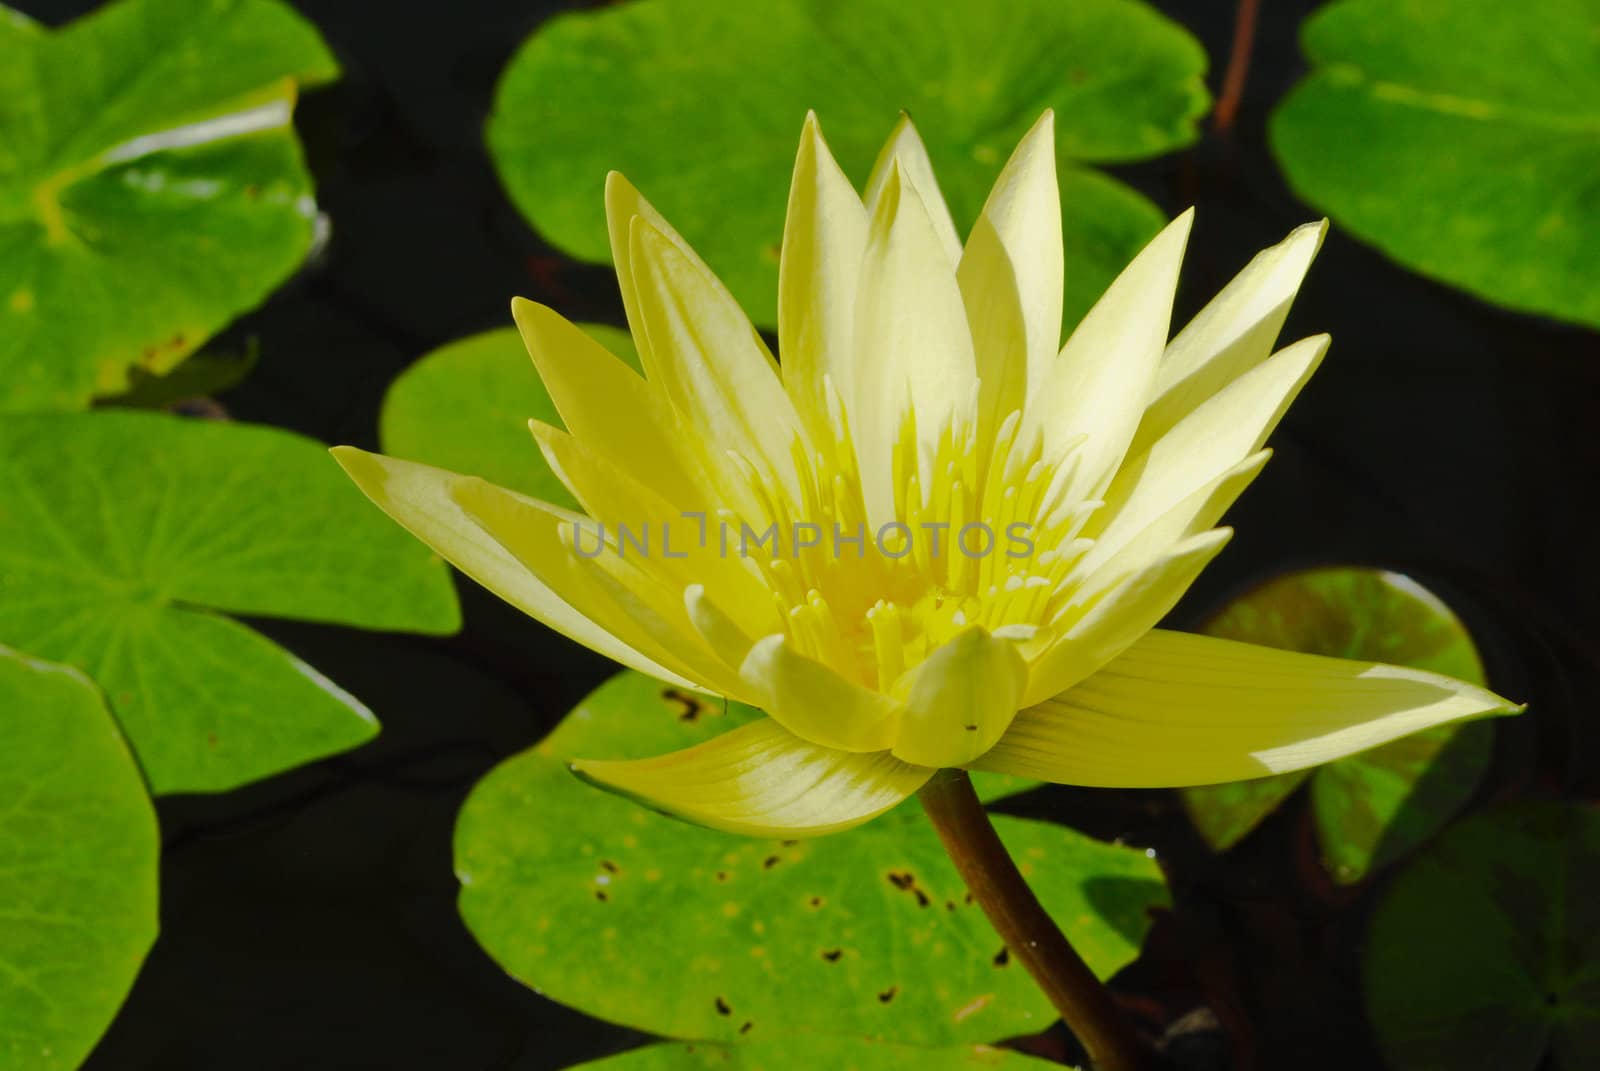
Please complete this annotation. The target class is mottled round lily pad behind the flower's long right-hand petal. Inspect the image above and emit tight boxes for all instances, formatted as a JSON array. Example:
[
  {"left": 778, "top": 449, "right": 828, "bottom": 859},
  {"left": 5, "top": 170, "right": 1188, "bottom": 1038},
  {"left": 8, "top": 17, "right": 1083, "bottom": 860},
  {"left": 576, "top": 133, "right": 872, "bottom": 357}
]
[{"left": 1182, "top": 568, "right": 1494, "bottom": 884}]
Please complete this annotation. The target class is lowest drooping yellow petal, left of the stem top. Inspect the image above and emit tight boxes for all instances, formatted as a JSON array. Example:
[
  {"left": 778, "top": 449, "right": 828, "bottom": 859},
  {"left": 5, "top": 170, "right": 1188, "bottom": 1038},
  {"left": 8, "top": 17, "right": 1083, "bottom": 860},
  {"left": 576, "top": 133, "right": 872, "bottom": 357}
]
[{"left": 573, "top": 717, "right": 933, "bottom": 837}]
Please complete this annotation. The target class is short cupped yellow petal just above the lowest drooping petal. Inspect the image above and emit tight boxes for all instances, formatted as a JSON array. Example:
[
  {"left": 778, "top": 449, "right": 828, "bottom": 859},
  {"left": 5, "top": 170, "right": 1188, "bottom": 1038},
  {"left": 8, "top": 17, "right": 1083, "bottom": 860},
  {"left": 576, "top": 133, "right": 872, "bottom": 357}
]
[{"left": 739, "top": 636, "right": 899, "bottom": 751}]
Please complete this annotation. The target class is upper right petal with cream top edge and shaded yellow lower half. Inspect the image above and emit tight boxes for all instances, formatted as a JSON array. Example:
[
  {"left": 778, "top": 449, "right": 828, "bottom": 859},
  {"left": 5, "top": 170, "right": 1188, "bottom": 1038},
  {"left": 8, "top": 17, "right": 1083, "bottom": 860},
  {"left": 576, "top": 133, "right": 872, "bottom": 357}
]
[{"left": 1138, "top": 219, "right": 1328, "bottom": 443}]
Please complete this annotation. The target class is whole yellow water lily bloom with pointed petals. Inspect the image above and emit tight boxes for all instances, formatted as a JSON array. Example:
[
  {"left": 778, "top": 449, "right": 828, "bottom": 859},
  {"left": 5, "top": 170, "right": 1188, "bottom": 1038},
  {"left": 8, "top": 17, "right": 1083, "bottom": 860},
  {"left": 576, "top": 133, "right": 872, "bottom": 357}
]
[{"left": 336, "top": 112, "right": 1509, "bottom": 836}]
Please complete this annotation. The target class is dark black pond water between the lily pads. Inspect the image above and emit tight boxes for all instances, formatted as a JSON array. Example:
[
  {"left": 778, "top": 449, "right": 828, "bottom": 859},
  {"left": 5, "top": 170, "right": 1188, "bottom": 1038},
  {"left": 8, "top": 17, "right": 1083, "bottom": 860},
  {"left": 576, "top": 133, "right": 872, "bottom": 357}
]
[{"left": 21, "top": 0, "right": 1600, "bottom": 1071}]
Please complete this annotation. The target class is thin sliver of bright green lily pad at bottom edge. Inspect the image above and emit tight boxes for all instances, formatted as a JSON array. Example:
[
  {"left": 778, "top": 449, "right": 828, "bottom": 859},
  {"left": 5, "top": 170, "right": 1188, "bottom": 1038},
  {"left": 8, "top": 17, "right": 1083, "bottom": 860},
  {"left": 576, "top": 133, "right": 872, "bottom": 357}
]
[{"left": 571, "top": 1037, "right": 1061, "bottom": 1071}]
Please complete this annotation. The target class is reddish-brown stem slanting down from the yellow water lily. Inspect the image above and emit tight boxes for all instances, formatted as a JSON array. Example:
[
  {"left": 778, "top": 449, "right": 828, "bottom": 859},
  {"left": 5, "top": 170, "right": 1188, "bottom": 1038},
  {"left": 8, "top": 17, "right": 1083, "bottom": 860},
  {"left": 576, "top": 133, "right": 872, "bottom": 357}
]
[{"left": 917, "top": 770, "right": 1150, "bottom": 1071}]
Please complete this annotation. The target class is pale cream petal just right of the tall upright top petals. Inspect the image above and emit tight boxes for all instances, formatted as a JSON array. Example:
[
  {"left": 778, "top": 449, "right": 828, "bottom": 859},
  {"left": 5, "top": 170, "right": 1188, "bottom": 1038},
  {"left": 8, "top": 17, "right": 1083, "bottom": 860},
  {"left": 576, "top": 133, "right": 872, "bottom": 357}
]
[{"left": 1024, "top": 210, "right": 1194, "bottom": 498}]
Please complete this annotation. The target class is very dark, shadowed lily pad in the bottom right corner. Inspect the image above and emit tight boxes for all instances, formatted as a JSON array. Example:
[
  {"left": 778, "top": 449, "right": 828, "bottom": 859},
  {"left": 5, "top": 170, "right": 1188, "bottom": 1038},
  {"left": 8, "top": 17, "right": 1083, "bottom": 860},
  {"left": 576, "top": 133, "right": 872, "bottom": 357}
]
[{"left": 1362, "top": 804, "right": 1600, "bottom": 1071}]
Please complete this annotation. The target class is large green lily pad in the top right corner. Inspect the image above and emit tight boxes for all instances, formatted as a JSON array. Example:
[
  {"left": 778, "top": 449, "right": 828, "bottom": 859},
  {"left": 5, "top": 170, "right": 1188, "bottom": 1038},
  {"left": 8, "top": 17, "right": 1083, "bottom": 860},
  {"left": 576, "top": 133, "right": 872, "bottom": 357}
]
[{"left": 1270, "top": 0, "right": 1600, "bottom": 327}]
